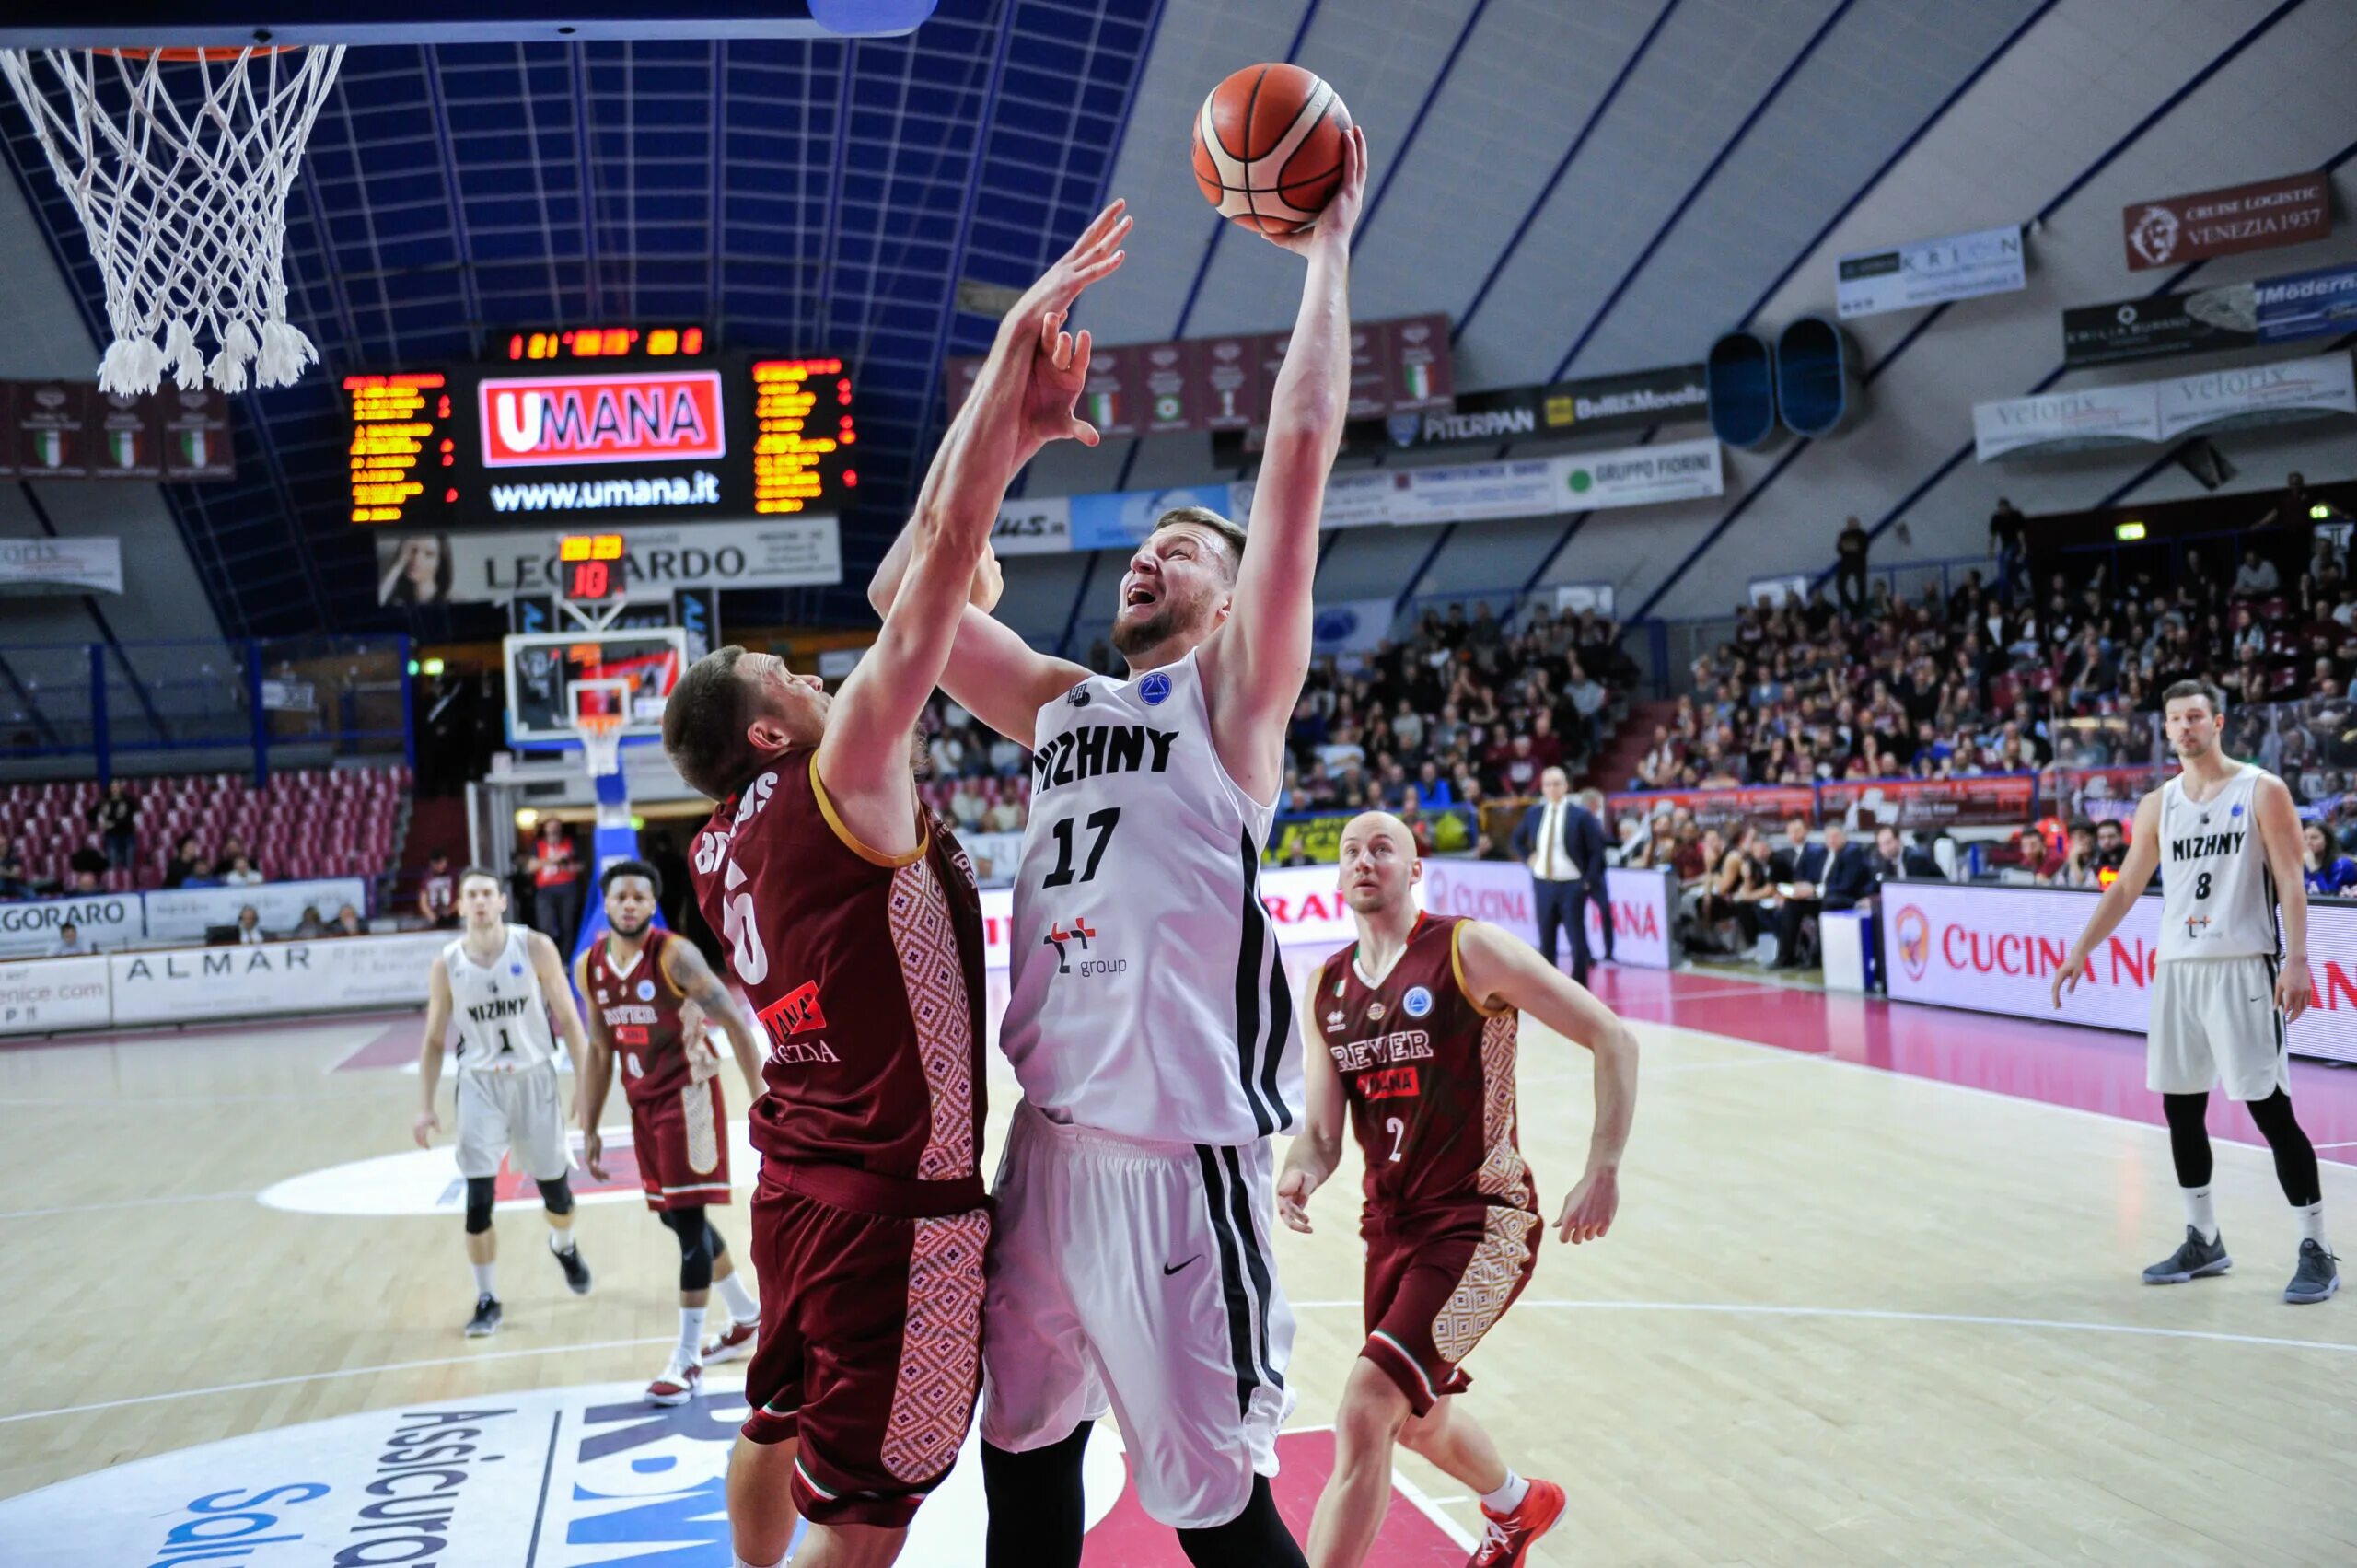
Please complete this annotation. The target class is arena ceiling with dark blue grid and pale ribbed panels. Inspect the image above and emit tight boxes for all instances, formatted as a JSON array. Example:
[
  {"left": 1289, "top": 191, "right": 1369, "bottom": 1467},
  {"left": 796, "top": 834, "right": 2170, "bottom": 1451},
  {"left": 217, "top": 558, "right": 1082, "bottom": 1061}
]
[{"left": 0, "top": 0, "right": 2357, "bottom": 634}]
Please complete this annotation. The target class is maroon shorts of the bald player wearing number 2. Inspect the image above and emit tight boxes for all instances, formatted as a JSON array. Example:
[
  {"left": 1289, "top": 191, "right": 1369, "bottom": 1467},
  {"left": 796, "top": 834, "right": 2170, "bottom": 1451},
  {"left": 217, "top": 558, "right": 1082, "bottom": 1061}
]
[{"left": 1360, "top": 1202, "right": 1546, "bottom": 1415}]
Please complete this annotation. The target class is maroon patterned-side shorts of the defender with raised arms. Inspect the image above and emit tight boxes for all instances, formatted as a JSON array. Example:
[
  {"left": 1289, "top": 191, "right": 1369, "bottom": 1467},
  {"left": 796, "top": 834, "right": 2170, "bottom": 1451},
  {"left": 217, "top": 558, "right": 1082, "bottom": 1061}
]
[{"left": 745, "top": 1163, "right": 990, "bottom": 1527}]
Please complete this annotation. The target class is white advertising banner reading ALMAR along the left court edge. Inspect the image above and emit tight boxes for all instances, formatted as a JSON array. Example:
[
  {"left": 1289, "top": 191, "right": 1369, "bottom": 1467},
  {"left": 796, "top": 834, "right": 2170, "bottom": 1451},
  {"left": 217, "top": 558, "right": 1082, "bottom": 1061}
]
[{"left": 106, "top": 932, "right": 450, "bottom": 1028}]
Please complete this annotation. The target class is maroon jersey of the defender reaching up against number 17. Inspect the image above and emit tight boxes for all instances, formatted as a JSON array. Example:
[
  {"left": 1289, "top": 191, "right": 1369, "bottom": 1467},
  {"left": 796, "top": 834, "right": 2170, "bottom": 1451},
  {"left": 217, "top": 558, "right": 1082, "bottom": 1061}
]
[{"left": 695, "top": 748, "right": 983, "bottom": 1197}]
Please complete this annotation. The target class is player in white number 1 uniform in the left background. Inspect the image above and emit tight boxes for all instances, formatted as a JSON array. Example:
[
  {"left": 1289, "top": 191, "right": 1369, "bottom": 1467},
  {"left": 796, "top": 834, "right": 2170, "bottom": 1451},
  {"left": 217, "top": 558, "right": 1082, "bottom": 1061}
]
[{"left": 410, "top": 865, "right": 589, "bottom": 1340}]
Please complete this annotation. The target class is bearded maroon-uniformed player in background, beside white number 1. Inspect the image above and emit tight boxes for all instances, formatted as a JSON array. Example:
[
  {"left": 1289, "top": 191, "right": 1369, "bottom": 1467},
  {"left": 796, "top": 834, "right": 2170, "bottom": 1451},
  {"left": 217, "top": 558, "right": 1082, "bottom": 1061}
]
[{"left": 573, "top": 861, "right": 761, "bottom": 1405}]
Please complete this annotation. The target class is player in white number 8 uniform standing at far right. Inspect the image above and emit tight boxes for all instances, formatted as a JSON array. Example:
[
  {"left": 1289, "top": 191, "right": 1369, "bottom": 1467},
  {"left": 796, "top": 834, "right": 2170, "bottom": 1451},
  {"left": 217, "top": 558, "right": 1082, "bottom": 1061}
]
[{"left": 2053, "top": 681, "right": 2340, "bottom": 1302}]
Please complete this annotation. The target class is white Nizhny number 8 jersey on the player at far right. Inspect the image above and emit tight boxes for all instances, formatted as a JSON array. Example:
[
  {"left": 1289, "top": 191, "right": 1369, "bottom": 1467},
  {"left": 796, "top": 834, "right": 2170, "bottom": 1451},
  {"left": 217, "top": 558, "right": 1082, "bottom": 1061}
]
[{"left": 2162, "top": 761, "right": 2277, "bottom": 959}]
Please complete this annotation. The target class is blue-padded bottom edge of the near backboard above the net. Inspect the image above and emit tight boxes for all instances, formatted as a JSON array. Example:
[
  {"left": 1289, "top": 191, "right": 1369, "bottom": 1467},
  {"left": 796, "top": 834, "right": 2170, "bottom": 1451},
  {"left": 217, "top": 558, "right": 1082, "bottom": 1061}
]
[{"left": 0, "top": 0, "right": 935, "bottom": 50}]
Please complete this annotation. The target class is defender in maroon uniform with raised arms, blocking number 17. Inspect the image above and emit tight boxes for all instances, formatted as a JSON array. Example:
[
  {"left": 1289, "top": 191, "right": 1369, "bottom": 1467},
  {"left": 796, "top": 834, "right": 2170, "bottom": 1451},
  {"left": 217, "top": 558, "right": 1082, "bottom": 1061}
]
[{"left": 662, "top": 203, "right": 1129, "bottom": 1568}]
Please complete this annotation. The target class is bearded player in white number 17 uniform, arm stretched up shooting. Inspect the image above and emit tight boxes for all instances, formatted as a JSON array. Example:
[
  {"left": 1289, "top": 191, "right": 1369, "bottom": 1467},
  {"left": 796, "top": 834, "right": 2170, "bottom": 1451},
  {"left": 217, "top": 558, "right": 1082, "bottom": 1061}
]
[{"left": 870, "top": 132, "right": 1367, "bottom": 1568}]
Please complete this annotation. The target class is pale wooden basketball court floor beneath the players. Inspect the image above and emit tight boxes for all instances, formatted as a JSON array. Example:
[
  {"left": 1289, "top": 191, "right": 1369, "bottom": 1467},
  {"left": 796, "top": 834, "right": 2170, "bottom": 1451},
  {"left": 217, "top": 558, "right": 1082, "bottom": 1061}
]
[{"left": 0, "top": 953, "right": 2357, "bottom": 1565}]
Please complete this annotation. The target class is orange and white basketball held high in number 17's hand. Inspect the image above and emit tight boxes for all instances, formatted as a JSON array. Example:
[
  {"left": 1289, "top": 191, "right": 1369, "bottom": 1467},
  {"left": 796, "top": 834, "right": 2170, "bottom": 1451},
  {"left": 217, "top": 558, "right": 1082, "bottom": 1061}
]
[{"left": 1195, "top": 66, "right": 1351, "bottom": 234}]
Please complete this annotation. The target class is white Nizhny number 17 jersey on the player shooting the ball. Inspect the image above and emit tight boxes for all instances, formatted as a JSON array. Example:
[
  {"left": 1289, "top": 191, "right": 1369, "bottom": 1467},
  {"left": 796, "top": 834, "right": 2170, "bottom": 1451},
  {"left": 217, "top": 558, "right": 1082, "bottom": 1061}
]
[{"left": 999, "top": 653, "right": 1301, "bottom": 1144}]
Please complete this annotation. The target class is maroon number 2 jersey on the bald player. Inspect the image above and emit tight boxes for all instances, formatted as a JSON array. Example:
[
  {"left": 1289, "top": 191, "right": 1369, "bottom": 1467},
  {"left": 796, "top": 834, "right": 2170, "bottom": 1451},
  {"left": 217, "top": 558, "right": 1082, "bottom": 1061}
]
[{"left": 1310, "top": 915, "right": 1537, "bottom": 1214}]
